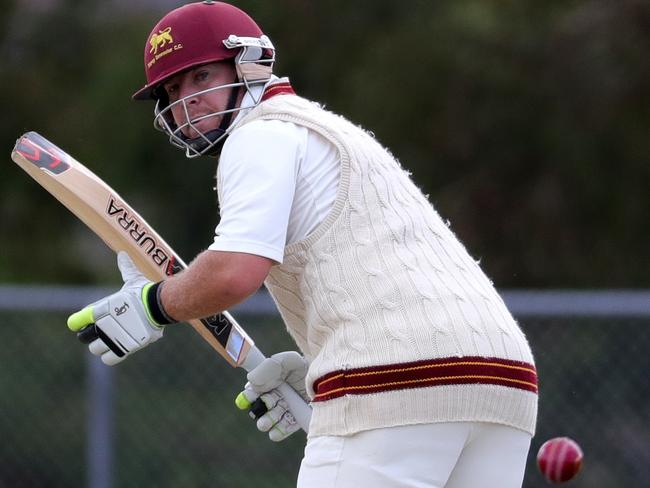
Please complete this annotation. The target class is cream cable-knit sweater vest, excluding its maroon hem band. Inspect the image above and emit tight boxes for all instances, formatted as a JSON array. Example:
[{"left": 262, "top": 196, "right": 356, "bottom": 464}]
[{"left": 230, "top": 95, "right": 537, "bottom": 436}]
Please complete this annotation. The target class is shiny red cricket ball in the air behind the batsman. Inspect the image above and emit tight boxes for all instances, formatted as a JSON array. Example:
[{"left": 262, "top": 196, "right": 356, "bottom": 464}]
[{"left": 537, "top": 437, "right": 582, "bottom": 483}]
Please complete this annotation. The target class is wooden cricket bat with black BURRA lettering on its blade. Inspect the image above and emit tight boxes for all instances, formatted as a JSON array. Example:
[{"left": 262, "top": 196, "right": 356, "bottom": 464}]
[{"left": 11, "top": 132, "right": 311, "bottom": 432}]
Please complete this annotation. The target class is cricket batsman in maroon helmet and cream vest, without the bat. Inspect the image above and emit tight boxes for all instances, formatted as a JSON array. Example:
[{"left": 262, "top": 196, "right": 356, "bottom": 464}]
[{"left": 73, "top": 1, "right": 538, "bottom": 488}]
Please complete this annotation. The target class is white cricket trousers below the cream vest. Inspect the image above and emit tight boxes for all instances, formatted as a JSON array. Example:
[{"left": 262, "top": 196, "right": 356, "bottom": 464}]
[{"left": 298, "top": 422, "right": 531, "bottom": 488}]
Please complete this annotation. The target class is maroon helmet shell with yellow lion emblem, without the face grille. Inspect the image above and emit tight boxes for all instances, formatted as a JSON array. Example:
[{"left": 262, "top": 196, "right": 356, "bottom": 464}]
[{"left": 133, "top": 0, "right": 263, "bottom": 100}]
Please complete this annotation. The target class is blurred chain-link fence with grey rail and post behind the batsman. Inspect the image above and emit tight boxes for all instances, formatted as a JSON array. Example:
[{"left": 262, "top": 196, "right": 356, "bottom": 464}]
[{"left": 0, "top": 287, "right": 650, "bottom": 488}]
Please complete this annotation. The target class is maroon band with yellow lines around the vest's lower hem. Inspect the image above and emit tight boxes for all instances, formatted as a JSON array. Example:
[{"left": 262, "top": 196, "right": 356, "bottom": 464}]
[{"left": 313, "top": 357, "right": 537, "bottom": 402}]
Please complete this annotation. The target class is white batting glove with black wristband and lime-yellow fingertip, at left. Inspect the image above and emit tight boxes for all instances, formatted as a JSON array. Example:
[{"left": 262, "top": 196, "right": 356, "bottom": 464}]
[{"left": 68, "top": 252, "right": 174, "bottom": 366}]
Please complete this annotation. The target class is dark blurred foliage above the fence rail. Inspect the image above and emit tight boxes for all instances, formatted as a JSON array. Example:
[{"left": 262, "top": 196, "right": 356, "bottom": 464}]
[{"left": 0, "top": 0, "right": 650, "bottom": 287}]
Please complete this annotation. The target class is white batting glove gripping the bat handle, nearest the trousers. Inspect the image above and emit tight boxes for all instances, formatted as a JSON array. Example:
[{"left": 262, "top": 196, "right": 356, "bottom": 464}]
[{"left": 235, "top": 351, "right": 309, "bottom": 442}]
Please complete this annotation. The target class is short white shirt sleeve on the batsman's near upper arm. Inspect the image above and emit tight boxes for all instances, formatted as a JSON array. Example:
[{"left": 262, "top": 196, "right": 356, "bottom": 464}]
[{"left": 208, "top": 120, "right": 306, "bottom": 263}]
